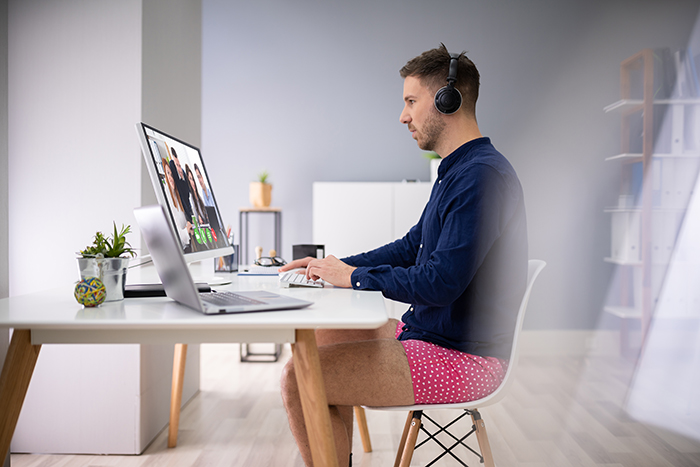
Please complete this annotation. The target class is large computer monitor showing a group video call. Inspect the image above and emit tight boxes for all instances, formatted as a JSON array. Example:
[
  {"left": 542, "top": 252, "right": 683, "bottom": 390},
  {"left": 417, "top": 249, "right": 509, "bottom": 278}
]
[{"left": 136, "top": 122, "right": 233, "bottom": 262}]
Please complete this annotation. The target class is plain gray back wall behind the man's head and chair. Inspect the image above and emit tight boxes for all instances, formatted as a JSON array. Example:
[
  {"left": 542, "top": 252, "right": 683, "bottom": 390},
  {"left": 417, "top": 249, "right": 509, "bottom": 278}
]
[{"left": 202, "top": 0, "right": 698, "bottom": 329}]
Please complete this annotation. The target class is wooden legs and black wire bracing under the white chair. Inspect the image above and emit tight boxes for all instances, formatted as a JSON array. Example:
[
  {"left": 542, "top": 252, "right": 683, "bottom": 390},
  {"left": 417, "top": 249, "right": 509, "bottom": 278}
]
[{"left": 397, "top": 409, "right": 491, "bottom": 467}]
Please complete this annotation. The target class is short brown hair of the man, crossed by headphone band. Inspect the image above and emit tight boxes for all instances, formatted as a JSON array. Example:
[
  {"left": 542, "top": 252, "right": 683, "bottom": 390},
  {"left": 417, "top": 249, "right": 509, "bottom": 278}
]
[{"left": 399, "top": 44, "right": 479, "bottom": 115}]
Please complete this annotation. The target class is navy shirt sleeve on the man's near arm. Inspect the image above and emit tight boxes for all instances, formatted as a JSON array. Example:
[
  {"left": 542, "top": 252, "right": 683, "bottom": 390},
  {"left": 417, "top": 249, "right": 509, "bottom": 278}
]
[{"left": 352, "top": 164, "right": 517, "bottom": 306}]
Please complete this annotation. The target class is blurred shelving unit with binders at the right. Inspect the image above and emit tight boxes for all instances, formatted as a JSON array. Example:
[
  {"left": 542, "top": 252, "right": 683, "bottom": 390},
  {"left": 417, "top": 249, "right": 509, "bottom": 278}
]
[{"left": 604, "top": 49, "right": 700, "bottom": 353}]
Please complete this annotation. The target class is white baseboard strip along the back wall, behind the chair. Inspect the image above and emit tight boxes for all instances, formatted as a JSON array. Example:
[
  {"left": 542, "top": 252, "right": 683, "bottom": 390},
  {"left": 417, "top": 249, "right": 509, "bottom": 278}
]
[{"left": 520, "top": 329, "right": 620, "bottom": 356}]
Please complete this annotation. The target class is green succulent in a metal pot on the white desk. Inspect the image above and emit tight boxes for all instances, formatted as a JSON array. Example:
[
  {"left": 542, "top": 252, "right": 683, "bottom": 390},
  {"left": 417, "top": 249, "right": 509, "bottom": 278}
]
[{"left": 78, "top": 223, "right": 136, "bottom": 302}]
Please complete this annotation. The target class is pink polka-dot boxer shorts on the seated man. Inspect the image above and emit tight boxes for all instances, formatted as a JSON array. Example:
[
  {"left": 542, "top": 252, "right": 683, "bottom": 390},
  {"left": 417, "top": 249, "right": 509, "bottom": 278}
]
[{"left": 396, "top": 322, "right": 508, "bottom": 404}]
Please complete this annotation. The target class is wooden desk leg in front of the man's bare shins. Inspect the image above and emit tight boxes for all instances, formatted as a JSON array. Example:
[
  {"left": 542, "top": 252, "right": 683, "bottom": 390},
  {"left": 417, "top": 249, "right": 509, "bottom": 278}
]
[{"left": 292, "top": 329, "right": 338, "bottom": 467}]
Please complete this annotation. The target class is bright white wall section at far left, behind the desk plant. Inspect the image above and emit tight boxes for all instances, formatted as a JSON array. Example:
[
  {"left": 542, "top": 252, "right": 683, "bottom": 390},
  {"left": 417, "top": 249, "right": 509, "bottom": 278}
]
[{"left": 9, "top": 0, "right": 141, "bottom": 295}]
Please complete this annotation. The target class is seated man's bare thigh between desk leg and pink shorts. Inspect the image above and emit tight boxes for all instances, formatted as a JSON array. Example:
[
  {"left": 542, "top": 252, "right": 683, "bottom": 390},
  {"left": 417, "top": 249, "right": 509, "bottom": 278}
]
[{"left": 319, "top": 334, "right": 413, "bottom": 406}]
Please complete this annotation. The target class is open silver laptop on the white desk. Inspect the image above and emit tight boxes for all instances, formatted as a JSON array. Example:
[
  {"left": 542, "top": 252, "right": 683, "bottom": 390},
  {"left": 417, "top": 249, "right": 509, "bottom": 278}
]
[{"left": 134, "top": 205, "right": 313, "bottom": 315}]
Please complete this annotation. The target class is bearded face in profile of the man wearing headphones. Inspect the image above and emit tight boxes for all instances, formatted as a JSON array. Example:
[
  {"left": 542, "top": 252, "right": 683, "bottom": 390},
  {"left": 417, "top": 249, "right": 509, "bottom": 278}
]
[{"left": 399, "top": 76, "right": 445, "bottom": 151}]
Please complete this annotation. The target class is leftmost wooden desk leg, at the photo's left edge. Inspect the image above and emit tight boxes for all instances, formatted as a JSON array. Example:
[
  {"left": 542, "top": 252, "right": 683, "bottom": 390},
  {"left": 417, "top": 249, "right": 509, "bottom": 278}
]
[{"left": 0, "top": 329, "right": 41, "bottom": 459}]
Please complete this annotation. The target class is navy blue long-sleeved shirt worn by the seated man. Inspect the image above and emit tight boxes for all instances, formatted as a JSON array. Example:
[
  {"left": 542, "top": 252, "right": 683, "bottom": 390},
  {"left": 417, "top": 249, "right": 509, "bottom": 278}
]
[{"left": 343, "top": 138, "right": 527, "bottom": 358}]
